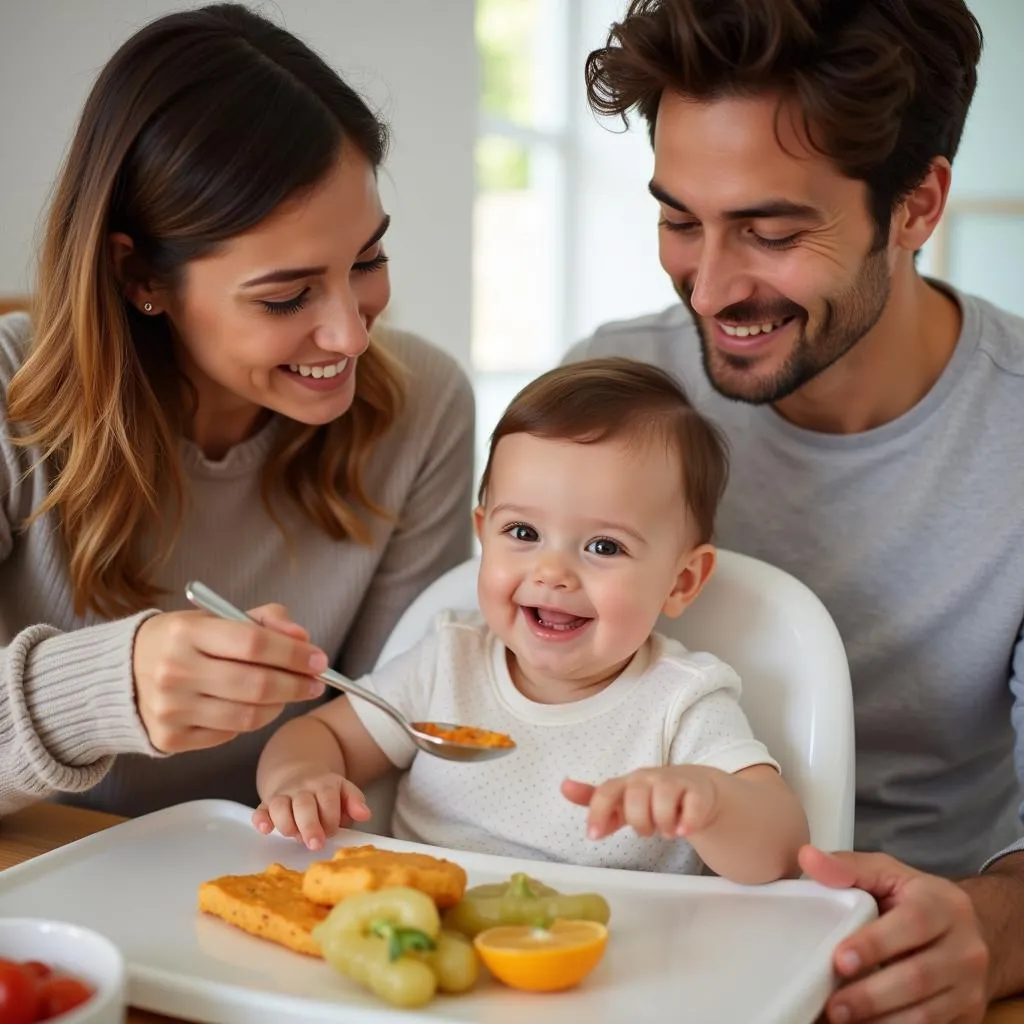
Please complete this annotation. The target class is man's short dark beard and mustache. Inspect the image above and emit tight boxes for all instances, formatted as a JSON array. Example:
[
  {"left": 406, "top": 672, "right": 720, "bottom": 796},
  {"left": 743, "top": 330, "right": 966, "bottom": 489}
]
[{"left": 676, "top": 249, "right": 890, "bottom": 406}]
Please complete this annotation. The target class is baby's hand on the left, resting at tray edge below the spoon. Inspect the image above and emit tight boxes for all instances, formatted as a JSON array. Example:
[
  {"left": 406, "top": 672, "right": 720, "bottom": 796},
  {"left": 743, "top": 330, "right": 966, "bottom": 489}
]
[{"left": 252, "top": 772, "right": 370, "bottom": 850}]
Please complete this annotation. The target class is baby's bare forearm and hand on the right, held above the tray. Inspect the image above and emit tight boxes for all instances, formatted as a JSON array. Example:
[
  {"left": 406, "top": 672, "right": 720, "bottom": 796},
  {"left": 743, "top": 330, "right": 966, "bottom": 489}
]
[{"left": 562, "top": 765, "right": 808, "bottom": 885}]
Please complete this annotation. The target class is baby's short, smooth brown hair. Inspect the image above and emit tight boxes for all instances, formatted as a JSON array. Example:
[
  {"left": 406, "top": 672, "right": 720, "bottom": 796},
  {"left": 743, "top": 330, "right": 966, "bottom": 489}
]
[{"left": 478, "top": 356, "right": 729, "bottom": 544}]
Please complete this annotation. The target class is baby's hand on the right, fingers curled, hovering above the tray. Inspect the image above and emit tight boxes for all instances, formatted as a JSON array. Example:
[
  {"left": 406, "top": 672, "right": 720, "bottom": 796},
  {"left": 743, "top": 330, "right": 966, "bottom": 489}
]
[{"left": 562, "top": 765, "right": 719, "bottom": 839}]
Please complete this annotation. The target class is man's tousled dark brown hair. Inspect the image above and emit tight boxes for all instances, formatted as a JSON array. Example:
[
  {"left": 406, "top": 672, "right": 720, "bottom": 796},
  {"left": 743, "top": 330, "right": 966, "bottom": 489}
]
[{"left": 586, "top": 0, "right": 982, "bottom": 243}]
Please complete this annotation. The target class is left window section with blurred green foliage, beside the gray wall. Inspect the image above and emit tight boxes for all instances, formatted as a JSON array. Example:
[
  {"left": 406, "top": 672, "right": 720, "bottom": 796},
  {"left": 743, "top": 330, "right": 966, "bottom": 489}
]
[{"left": 472, "top": 0, "right": 568, "bottom": 464}]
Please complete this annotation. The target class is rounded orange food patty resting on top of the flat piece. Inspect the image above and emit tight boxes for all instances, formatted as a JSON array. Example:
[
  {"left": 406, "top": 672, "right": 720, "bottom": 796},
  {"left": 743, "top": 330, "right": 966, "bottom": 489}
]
[{"left": 302, "top": 846, "right": 466, "bottom": 908}]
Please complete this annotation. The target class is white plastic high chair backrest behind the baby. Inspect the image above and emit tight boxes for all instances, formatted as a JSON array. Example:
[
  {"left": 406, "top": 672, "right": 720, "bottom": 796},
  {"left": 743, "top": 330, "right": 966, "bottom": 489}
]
[{"left": 359, "top": 550, "right": 854, "bottom": 850}]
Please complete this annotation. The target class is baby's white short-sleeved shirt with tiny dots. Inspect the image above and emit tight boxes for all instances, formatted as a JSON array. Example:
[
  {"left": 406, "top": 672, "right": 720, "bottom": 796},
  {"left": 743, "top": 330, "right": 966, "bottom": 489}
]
[{"left": 352, "top": 612, "right": 778, "bottom": 873}]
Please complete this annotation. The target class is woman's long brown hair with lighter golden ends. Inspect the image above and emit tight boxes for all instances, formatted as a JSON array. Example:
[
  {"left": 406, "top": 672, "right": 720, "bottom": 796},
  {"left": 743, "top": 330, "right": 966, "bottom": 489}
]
[{"left": 7, "top": 4, "right": 402, "bottom": 615}]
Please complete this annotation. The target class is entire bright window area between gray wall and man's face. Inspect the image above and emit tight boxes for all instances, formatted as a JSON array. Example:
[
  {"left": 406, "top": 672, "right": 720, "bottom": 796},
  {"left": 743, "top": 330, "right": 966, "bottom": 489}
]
[{"left": 472, "top": 0, "right": 678, "bottom": 468}]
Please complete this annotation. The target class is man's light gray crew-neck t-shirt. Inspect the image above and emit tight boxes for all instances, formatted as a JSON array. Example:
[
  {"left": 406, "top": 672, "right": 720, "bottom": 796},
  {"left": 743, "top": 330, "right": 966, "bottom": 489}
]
[{"left": 566, "top": 295, "right": 1024, "bottom": 876}]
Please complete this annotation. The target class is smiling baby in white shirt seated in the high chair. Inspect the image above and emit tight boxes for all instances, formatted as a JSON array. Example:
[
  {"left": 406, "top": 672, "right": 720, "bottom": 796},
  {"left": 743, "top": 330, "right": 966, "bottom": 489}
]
[{"left": 253, "top": 358, "right": 808, "bottom": 884}]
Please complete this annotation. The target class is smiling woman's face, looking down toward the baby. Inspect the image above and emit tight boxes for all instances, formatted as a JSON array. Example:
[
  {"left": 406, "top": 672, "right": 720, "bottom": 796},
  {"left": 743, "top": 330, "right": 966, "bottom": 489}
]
[{"left": 155, "top": 147, "right": 390, "bottom": 458}]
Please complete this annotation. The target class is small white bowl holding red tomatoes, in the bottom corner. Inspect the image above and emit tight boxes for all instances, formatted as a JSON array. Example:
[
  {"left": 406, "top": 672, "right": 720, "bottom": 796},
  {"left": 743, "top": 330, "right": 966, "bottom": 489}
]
[{"left": 0, "top": 918, "right": 125, "bottom": 1024}]
